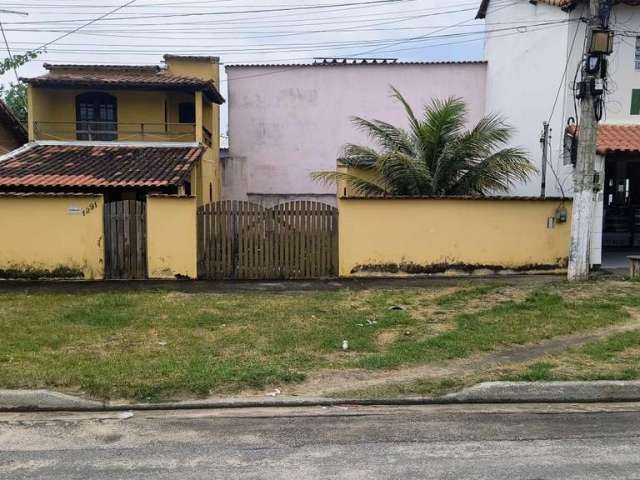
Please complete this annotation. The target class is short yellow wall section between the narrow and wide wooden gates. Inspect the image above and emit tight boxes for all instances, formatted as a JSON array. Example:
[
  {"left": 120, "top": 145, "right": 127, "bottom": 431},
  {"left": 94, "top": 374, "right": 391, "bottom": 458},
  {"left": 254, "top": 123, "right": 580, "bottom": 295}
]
[{"left": 147, "top": 195, "right": 198, "bottom": 279}]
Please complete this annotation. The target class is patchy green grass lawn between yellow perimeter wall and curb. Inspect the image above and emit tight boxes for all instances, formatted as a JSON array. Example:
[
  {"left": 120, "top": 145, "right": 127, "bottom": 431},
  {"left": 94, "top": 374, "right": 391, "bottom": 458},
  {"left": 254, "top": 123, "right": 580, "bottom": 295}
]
[{"left": 0, "top": 280, "right": 640, "bottom": 400}]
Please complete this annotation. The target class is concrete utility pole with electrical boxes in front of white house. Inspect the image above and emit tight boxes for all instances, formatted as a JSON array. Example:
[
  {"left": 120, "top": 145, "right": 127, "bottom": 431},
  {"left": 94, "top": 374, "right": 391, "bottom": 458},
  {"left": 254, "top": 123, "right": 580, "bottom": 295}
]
[{"left": 568, "top": 0, "right": 613, "bottom": 281}]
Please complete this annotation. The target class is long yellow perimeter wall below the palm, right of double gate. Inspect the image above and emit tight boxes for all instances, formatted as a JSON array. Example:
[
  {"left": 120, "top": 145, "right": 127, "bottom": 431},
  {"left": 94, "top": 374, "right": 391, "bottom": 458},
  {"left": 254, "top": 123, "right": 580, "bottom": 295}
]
[{"left": 338, "top": 198, "right": 571, "bottom": 276}]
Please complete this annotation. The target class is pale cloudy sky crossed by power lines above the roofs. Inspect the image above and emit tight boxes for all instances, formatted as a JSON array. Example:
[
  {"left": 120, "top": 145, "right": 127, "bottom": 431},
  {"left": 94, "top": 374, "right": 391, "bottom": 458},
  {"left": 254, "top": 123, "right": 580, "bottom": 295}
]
[{"left": 0, "top": 0, "right": 496, "bottom": 137}]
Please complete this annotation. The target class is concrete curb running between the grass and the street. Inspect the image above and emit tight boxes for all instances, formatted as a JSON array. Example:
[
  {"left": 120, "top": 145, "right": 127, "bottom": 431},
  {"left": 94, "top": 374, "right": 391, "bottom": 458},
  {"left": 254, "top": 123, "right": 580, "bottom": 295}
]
[{"left": 0, "top": 381, "right": 640, "bottom": 412}]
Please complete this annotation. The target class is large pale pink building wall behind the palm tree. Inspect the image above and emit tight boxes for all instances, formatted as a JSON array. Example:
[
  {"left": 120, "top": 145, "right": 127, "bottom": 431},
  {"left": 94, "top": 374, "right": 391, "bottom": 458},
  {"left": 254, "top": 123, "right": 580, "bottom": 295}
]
[{"left": 223, "top": 62, "right": 486, "bottom": 206}]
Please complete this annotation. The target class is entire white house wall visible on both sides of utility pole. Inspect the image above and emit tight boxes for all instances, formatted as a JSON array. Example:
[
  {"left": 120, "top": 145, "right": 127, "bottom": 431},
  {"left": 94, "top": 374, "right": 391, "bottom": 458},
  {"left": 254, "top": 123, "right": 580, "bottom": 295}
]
[{"left": 485, "top": 0, "right": 640, "bottom": 264}]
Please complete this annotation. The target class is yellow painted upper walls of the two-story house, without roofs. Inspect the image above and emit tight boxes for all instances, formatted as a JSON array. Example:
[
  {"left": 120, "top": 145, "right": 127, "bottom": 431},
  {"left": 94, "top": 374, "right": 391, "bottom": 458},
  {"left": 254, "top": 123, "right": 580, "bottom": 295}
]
[{"left": 27, "top": 57, "right": 222, "bottom": 205}]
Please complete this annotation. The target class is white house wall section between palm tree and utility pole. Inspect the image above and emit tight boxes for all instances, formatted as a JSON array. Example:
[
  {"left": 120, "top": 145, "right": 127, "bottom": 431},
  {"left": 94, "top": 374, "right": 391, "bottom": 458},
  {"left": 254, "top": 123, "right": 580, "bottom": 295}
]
[{"left": 485, "top": 1, "right": 582, "bottom": 196}]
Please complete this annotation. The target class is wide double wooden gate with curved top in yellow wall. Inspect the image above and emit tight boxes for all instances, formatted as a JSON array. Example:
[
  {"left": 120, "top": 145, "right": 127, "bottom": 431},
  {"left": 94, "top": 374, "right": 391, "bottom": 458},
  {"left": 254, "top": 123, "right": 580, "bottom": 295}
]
[{"left": 198, "top": 200, "right": 338, "bottom": 279}]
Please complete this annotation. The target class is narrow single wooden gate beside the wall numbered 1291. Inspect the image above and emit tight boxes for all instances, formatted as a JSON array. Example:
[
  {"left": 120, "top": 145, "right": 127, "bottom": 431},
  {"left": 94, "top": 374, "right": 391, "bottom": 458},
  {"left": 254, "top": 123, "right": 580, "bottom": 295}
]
[{"left": 104, "top": 200, "right": 147, "bottom": 280}]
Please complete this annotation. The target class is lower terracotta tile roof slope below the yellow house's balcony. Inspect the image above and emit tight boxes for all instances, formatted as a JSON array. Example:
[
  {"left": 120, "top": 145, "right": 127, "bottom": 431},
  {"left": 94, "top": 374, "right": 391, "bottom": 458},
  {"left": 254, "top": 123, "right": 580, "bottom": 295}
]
[{"left": 0, "top": 143, "right": 204, "bottom": 190}]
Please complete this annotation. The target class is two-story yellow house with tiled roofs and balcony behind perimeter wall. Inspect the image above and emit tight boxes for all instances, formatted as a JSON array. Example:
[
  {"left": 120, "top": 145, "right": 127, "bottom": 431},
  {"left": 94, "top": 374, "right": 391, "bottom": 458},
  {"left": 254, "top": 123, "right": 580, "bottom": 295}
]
[{"left": 0, "top": 55, "right": 224, "bottom": 205}]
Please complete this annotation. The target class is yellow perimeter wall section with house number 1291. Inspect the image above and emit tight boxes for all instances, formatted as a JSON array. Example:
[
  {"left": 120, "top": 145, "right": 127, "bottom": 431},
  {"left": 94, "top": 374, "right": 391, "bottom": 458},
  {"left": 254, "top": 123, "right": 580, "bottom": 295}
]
[{"left": 0, "top": 194, "right": 104, "bottom": 279}]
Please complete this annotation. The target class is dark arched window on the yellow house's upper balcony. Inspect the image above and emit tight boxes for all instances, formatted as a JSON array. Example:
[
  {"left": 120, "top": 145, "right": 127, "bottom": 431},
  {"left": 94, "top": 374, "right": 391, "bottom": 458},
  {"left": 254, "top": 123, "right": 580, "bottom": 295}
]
[{"left": 76, "top": 92, "right": 118, "bottom": 141}]
